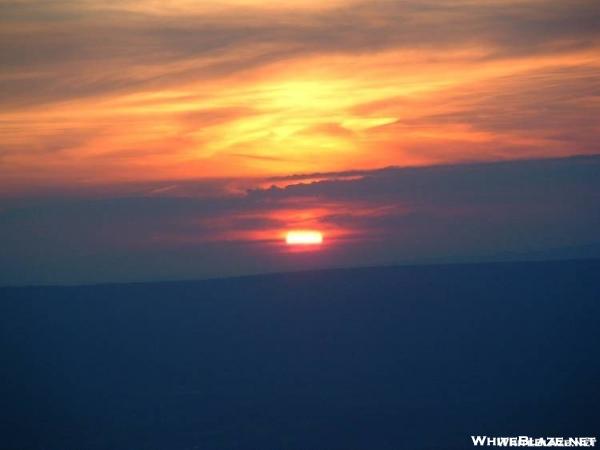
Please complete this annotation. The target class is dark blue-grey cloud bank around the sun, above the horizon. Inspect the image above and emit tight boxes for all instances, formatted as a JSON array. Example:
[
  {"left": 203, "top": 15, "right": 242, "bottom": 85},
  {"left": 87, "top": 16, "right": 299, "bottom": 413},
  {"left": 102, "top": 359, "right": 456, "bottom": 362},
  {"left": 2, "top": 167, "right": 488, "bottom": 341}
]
[{"left": 0, "top": 157, "right": 600, "bottom": 284}]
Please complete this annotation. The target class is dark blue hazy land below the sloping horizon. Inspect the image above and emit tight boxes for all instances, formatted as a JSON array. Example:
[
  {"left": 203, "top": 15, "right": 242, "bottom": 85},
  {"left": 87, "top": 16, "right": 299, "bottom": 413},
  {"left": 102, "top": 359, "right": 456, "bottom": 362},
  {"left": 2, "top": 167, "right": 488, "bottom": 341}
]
[{"left": 0, "top": 260, "right": 600, "bottom": 450}]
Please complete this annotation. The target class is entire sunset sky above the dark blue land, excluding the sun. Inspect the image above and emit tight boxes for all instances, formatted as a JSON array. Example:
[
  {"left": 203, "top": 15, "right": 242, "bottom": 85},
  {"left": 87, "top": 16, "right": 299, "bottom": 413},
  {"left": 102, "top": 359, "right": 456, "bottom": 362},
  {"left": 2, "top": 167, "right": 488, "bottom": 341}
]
[{"left": 0, "top": 0, "right": 600, "bottom": 284}]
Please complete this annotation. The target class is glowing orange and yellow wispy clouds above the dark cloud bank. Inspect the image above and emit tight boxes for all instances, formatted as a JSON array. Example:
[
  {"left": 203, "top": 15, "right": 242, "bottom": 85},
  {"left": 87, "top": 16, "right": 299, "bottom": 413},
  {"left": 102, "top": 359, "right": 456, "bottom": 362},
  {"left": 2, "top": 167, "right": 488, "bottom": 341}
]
[{"left": 0, "top": 0, "right": 600, "bottom": 190}]
